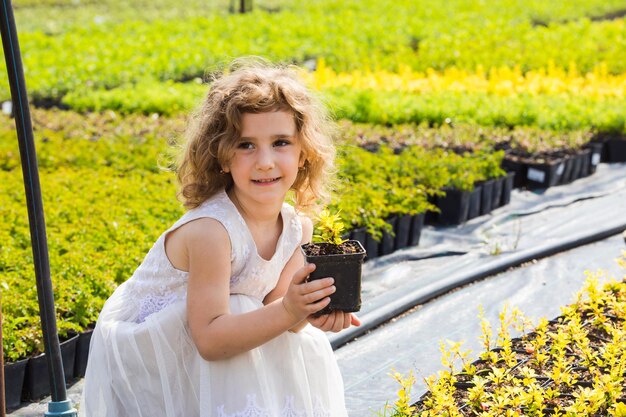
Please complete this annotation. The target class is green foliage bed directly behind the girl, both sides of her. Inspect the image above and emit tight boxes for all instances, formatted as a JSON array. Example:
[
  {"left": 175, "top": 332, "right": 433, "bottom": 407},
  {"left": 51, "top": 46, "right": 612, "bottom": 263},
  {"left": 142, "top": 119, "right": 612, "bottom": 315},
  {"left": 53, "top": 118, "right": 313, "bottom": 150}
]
[{"left": 0, "top": 110, "right": 503, "bottom": 360}]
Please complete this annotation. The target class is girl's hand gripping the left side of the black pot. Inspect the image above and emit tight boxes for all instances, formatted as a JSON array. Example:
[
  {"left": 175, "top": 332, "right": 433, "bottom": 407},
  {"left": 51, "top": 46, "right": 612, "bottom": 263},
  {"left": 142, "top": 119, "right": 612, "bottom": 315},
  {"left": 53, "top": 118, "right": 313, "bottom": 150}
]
[{"left": 282, "top": 264, "right": 335, "bottom": 322}]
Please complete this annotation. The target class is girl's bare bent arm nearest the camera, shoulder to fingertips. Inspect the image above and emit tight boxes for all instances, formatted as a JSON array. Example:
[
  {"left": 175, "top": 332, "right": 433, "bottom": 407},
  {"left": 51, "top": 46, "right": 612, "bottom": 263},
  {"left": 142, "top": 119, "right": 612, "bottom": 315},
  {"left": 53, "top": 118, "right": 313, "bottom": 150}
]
[{"left": 183, "top": 218, "right": 335, "bottom": 360}]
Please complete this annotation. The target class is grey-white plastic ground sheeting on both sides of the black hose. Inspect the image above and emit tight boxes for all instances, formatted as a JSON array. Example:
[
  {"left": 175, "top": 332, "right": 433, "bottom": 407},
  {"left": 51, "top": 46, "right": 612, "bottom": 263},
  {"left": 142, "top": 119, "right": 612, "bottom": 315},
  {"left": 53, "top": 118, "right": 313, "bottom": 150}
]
[{"left": 330, "top": 164, "right": 626, "bottom": 417}]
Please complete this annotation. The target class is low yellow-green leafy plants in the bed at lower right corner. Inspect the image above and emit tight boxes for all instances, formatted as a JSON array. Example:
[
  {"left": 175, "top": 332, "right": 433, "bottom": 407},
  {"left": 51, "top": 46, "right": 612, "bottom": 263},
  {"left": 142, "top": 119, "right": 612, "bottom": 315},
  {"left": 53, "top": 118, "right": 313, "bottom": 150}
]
[{"left": 408, "top": 270, "right": 626, "bottom": 416}]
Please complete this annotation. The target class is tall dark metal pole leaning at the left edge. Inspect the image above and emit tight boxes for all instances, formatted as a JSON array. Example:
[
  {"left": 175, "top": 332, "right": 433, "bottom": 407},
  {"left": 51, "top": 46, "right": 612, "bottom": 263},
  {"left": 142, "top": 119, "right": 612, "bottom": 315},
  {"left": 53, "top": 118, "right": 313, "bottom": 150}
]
[{"left": 0, "top": 0, "right": 77, "bottom": 416}]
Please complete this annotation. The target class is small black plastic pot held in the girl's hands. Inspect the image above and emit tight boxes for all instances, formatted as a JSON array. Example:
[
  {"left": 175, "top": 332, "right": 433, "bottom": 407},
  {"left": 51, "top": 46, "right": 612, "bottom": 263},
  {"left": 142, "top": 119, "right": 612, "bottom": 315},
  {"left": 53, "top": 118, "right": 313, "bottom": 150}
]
[{"left": 301, "top": 240, "right": 365, "bottom": 315}]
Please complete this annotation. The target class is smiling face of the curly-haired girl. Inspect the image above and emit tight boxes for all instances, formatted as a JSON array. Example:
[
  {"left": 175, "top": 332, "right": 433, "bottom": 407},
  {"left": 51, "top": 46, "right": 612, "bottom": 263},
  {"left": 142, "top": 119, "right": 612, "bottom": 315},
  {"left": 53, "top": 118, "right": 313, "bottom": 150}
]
[{"left": 224, "top": 111, "right": 304, "bottom": 204}]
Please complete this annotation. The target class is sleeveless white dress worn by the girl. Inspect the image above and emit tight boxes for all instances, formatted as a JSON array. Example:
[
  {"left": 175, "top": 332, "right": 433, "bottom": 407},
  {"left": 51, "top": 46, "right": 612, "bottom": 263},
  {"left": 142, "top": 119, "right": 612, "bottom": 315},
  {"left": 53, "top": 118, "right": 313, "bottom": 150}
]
[{"left": 79, "top": 191, "right": 347, "bottom": 417}]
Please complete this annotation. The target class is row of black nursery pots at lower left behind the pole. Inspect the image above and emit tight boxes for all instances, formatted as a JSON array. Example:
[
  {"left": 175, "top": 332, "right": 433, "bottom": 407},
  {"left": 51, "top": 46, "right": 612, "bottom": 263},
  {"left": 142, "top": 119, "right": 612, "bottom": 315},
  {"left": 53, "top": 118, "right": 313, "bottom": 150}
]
[{"left": 4, "top": 324, "right": 92, "bottom": 410}]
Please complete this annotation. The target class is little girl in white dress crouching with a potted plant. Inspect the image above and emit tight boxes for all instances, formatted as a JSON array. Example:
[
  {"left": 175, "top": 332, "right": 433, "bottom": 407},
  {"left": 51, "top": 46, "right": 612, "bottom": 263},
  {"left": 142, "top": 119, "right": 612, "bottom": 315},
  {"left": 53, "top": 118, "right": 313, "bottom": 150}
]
[{"left": 80, "top": 59, "right": 360, "bottom": 417}]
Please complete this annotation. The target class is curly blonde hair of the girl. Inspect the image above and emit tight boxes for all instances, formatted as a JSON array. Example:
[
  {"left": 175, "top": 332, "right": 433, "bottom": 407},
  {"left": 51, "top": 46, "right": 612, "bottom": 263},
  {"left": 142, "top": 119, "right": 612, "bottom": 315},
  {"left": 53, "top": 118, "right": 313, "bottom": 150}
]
[{"left": 177, "top": 59, "right": 336, "bottom": 213}]
